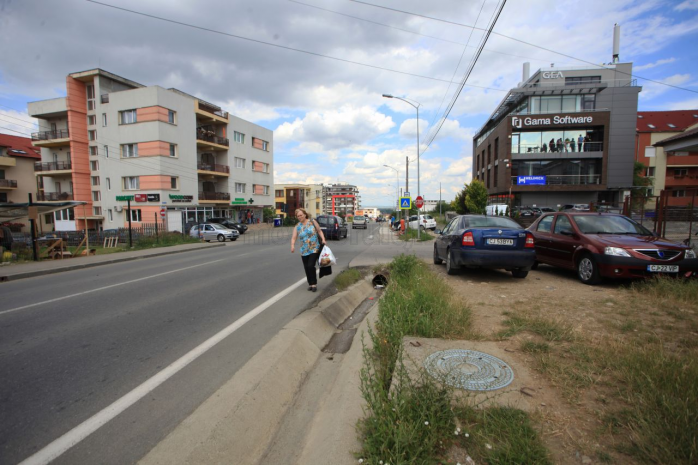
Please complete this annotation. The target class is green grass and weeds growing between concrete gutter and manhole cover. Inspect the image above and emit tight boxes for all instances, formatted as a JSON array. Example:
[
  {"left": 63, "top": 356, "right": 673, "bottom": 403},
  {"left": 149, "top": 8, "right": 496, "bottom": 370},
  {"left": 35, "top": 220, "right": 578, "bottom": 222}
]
[{"left": 357, "top": 255, "right": 550, "bottom": 464}]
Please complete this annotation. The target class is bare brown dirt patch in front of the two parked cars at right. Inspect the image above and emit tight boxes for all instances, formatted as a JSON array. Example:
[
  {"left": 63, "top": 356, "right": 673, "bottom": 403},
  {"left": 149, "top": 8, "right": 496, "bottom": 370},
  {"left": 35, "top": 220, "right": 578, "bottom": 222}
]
[{"left": 431, "top": 265, "right": 698, "bottom": 463}]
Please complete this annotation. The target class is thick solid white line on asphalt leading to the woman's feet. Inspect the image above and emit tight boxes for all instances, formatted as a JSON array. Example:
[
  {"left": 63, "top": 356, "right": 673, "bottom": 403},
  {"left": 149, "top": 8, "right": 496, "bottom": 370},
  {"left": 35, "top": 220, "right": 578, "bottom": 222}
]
[{"left": 19, "top": 278, "right": 306, "bottom": 465}]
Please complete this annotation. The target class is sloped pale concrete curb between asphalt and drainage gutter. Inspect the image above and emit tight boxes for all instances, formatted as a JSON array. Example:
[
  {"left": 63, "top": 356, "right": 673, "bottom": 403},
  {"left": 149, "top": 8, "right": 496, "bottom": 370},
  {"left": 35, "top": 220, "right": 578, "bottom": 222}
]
[{"left": 139, "top": 280, "right": 373, "bottom": 464}]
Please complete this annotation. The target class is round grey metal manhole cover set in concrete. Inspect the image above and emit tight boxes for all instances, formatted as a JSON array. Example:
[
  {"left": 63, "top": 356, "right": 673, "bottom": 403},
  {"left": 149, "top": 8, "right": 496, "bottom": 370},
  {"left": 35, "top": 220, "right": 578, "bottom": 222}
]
[{"left": 424, "top": 349, "right": 514, "bottom": 391}]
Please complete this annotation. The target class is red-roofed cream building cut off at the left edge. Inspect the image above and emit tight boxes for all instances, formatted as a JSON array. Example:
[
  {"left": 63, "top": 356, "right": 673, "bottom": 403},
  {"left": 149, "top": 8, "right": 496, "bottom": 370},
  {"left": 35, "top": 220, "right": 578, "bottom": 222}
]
[{"left": 0, "top": 134, "right": 41, "bottom": 231}]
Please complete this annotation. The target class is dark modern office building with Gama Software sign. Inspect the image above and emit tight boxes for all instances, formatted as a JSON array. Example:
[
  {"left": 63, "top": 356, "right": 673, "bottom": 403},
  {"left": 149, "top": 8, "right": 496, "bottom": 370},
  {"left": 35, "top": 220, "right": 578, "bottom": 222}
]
[{"left": 472, "top": 43, "right": 641, "bottom": 207}]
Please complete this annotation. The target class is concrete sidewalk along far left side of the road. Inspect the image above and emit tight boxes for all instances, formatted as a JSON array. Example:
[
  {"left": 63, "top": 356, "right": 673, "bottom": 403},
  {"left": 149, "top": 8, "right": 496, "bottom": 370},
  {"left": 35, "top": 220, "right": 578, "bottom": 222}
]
[{"left": 0, "top": 242, "right": 225, "bottom": 282}]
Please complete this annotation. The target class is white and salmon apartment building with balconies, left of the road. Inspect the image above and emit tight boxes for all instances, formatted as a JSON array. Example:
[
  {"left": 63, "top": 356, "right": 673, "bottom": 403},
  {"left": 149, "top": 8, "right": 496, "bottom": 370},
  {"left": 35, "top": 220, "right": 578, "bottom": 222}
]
[{"left": 28, "top": 69, "right": 274, "bottom": 231}]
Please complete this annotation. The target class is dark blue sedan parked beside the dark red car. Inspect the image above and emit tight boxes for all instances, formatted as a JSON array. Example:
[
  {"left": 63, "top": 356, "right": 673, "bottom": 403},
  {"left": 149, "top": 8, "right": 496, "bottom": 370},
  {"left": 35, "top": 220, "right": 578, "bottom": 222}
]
[{"left": 434, "top": 215, "right": 536, "bottom": 278}]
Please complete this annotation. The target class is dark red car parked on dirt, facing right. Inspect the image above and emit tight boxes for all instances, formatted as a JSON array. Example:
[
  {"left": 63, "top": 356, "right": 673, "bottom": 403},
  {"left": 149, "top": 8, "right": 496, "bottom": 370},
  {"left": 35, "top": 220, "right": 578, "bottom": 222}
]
[{"left": 528, "top": 211, "right": 698, "bottom": 284}]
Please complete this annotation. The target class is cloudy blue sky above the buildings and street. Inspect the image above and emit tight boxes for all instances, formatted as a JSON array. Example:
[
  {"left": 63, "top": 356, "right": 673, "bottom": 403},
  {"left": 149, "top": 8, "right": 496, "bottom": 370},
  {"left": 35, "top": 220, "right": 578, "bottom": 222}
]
[{"left": 0, "top": 0, "right": 698, "bottom": 207}]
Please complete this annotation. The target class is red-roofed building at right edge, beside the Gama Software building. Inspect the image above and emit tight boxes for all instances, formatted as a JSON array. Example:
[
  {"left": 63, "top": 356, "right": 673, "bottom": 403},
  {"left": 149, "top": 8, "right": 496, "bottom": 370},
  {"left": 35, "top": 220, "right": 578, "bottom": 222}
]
[{"left": 635, "top": 110, "right": 698, "bottom": 206}]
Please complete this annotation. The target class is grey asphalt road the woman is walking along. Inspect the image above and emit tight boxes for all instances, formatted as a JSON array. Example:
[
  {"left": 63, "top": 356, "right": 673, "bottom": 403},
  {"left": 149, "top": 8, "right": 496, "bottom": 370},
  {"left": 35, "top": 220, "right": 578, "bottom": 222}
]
[{"left": 0, "top": 223, "right": 378, "bottom": 464}]
